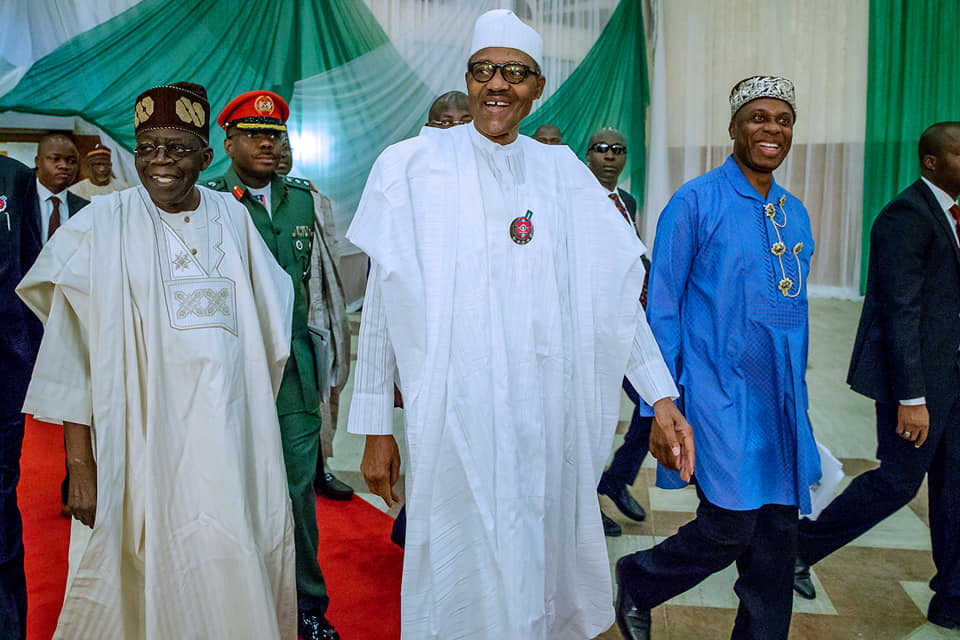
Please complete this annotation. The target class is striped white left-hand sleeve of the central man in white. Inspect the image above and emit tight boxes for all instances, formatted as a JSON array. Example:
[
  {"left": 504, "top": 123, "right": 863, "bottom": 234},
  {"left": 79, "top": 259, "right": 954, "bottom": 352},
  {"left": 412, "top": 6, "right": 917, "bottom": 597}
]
[{"left": 347, "top": 262, "right": 397, "bottom": 435}]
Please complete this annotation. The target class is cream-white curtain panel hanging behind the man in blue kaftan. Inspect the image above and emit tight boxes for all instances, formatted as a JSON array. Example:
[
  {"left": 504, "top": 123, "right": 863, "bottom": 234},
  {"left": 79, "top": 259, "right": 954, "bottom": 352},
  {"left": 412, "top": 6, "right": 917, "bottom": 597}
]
[{"left": 642, "top": 0, "right": 869, "bottom": 297}]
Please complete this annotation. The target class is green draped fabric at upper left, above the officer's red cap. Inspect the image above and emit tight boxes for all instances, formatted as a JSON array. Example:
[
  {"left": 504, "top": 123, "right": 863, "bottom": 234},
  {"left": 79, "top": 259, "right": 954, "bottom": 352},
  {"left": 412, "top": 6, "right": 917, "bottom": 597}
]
[{"left": 0, "top": 0, "right": 388, "bottom": 175}]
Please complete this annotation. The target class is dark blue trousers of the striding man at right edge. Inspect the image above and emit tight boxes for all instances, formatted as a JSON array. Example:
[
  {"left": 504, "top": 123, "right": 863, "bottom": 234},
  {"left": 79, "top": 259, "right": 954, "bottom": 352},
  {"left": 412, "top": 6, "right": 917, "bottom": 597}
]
[{"left": 798, "top": 399, "right": 960, "bottom": 604}]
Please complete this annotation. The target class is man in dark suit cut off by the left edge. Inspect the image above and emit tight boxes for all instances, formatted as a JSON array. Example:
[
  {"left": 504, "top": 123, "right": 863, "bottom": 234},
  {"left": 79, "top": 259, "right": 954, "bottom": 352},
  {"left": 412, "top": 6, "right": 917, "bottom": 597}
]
[{"left": 0, "top": 156, "right": 41, "bottom": 640}]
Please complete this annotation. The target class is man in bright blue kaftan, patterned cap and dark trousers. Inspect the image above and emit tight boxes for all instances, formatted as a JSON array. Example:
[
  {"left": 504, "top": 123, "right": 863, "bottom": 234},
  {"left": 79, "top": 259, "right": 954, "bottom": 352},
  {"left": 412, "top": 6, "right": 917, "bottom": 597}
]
[{"left": 617, "top": 76, "right": 820, "bottom": 640}]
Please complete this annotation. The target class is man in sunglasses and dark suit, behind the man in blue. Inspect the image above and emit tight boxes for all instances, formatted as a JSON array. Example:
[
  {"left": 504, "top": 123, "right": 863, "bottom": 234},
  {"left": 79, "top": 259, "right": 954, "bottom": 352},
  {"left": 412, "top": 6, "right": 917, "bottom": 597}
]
[{"left": 587, "top": 127, "right": 652, "bottom": 537}]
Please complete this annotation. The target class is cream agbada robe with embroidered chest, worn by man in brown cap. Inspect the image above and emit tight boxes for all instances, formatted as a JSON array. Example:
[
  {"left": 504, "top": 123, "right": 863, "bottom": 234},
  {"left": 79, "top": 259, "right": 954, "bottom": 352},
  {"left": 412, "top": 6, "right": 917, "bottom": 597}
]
[{"left": 18, "top": 187, "right": 296, "bottom": 640}]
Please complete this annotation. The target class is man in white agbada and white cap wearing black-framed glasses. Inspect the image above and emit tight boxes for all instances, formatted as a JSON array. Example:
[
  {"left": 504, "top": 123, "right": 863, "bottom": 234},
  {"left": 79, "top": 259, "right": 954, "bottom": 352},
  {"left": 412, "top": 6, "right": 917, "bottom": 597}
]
[{"left": 347, "top": 10, "right": 693, "bottom": 640}]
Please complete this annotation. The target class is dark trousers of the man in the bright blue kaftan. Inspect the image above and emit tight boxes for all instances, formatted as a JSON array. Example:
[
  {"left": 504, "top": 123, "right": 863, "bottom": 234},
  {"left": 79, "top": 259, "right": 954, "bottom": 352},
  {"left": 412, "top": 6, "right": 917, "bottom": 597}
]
[{"left": 620, "top": 487, "right": 797, "bottom": 640}]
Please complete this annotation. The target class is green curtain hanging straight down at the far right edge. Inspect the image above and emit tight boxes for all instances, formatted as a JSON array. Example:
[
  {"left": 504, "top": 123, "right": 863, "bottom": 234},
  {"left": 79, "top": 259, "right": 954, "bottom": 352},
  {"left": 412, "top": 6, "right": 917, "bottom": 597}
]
[{"left": 860, "top": 0, "right": 960, "bottom": 293}]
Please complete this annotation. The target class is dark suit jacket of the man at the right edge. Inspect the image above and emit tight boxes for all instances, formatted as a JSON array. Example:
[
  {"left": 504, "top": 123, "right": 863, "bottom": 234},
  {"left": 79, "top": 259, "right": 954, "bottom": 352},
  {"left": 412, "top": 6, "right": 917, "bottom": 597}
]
[{"left": 847, "top": 180, "right": 960, "bottom": 412}]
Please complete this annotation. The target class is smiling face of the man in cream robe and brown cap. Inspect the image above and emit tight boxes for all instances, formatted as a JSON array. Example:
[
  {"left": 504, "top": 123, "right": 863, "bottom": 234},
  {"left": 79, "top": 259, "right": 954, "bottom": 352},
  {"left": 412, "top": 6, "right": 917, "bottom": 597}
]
[{"left": 134, "top": 129, "right": 213, "bottom": 213}]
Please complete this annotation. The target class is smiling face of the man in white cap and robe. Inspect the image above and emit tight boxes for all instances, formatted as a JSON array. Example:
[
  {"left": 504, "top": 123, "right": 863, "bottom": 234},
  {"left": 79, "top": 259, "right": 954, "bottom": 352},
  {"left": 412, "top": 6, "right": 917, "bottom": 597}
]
[{"left": 466, "top": 47, "right": 546, "bottom": 144}]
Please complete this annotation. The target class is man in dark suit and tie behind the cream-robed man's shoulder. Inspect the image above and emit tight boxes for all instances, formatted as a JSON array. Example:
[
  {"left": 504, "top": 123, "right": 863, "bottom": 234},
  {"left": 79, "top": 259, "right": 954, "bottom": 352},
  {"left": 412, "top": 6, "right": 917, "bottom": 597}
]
[{"left": 34, "top": 133, "right": 90, "bottom": 518}]
